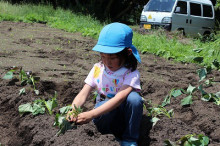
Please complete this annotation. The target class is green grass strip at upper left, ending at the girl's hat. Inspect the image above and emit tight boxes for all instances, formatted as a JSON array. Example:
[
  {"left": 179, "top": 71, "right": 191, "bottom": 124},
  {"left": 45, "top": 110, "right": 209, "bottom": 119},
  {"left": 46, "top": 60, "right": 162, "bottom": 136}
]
[{"left": 0, "top": 2, "right": 103, "bottom": 39}]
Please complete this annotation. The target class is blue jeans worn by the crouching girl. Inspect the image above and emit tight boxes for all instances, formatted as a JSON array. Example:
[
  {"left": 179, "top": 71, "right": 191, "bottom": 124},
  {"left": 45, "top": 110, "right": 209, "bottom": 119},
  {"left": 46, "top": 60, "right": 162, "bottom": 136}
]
[{"left": 93, "top": 92, "right": 143, "bottom": 141}]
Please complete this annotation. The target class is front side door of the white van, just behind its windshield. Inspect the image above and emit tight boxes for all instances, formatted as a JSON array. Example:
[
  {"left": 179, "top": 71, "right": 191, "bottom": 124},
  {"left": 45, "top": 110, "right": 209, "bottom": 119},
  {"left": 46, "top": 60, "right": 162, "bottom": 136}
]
[{"left": 171, "top": 1, "right": 189, "bottom": 33}]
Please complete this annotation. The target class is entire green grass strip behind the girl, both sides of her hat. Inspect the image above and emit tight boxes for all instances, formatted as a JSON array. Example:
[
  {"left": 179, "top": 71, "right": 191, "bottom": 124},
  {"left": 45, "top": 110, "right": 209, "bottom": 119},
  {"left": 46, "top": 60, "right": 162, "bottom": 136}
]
[{"left": 0, "top": 1, "right": 220, "bottom": 70}]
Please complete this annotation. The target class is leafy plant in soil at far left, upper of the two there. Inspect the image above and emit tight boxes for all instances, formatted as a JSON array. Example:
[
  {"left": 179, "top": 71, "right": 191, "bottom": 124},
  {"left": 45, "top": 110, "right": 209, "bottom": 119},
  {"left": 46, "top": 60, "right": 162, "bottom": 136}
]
[{"left": 3, "top": 67, "right": 40, "bottom": 95}]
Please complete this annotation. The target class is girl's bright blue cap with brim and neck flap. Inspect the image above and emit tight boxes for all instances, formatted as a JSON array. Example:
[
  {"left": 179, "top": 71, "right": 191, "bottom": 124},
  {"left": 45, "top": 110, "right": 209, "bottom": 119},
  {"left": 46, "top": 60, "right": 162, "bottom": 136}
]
[{"left": 92, "top": 22, "right": 141, "bottom": 63}]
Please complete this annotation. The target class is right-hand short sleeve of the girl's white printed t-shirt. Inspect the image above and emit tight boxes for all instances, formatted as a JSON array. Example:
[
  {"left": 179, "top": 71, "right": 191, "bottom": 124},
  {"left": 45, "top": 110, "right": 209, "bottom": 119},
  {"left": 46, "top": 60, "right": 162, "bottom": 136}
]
[{"left": 123, "top": 70, "right": 141, "bottom": 90}]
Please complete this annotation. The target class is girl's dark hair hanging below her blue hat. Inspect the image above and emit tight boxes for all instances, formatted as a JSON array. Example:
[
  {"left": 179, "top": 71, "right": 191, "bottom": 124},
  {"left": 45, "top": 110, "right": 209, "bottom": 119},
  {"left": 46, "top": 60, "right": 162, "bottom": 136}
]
[{"left": 116, "top": 48, "right": 137, "bottom": 71}]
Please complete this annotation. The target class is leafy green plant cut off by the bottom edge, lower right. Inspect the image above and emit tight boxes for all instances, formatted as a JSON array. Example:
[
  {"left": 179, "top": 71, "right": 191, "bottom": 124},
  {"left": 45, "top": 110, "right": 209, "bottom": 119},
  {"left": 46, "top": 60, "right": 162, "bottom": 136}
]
[{"left": 164, "top": 134, "right": 209, "bottom": 146}]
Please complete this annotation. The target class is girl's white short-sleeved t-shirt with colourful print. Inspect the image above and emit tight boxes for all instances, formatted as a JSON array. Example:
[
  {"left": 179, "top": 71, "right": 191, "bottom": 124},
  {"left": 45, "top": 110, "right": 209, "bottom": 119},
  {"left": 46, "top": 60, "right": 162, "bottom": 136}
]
[{"left": 85, "top": 62, "right": 141, "bottom": 101}]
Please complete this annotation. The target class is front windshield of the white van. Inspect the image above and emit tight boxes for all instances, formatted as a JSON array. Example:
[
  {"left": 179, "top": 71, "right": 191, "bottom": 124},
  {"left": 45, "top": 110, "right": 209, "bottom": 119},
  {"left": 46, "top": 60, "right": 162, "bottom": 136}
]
[{"left": 144, "top": 0, "right": 176, "bottom": 12}]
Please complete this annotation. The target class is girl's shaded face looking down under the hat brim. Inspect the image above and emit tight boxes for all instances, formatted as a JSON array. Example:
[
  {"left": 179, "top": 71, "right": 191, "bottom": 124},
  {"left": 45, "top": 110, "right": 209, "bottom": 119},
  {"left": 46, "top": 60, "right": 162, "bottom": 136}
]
[{"left": 100, "top": 53, "right": 124, "bottom": 71}]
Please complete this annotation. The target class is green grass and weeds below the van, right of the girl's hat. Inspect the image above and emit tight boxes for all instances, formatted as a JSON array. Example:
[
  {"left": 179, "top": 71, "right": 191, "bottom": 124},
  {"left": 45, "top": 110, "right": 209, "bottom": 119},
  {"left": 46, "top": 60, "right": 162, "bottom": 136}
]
[{"left": 134, "top": 31, "right": 220, "bottom": 69}]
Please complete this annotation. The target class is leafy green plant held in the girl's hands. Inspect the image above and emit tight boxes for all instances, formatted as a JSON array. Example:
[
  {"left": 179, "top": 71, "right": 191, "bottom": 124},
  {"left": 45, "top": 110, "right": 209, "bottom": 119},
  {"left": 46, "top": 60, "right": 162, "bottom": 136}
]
[{"left": 54, "top": 105, "right": 83, "bottom": 136}]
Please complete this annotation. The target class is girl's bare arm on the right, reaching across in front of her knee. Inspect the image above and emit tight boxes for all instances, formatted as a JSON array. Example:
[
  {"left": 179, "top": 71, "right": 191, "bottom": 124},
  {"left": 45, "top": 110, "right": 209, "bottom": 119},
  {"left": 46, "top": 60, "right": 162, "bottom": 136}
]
[{"left": 77, "top": 85, "right": 133, "bottom": 124}]
